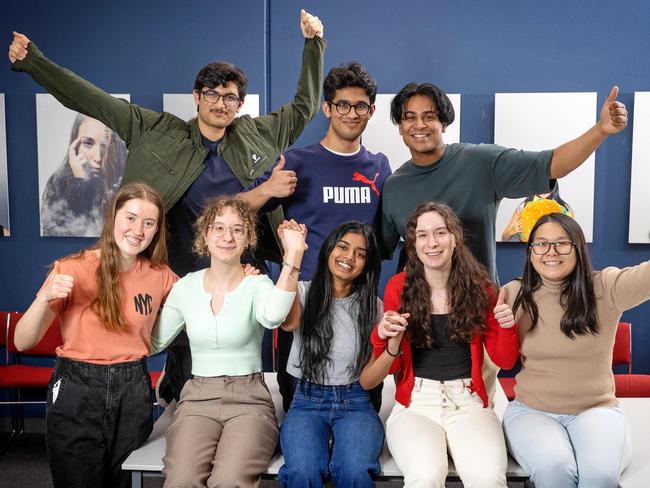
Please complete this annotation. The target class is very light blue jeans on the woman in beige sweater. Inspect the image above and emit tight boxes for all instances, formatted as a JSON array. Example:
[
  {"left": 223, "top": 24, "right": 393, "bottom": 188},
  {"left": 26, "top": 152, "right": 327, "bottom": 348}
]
[{"left": 503, "top": 400, "right": 632, "bottom": 488}]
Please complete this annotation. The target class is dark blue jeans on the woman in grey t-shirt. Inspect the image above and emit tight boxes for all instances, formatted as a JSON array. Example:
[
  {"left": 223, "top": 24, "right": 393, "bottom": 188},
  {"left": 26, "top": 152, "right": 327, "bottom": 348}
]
[{"left": 278, "top": 381, "right": 384, "bottom": 488}]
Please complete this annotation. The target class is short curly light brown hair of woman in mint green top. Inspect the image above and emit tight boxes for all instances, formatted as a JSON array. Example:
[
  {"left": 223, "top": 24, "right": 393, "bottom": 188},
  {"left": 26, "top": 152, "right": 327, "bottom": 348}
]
[{"left": 192, "top": 195, "right": 257, "bottom": 256}]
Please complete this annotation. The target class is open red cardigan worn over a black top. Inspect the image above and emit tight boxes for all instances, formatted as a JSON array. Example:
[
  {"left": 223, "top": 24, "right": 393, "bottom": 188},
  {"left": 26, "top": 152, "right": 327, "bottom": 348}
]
[{"left": 370, "top": 272, "right": 519, "bottom": 407}]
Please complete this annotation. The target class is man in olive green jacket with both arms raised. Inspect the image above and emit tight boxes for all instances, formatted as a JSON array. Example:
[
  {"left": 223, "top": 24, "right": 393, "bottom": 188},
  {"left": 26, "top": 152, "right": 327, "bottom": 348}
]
[{"left": 9, "top": 10, "right": 326, "bottom": 398}]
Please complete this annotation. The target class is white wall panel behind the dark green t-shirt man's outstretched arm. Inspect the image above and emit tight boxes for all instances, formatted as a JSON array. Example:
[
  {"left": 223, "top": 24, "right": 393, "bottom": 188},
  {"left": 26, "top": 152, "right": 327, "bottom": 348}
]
[{"left": 494, "top": 92, "right": 598, "bottom": 242}]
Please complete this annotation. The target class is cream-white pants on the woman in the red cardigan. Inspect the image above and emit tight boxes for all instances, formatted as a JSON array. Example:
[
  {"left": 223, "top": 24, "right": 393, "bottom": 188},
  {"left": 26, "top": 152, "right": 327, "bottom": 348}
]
[{"left": 386, "top": 378, "right": 508, "bottom": 488}]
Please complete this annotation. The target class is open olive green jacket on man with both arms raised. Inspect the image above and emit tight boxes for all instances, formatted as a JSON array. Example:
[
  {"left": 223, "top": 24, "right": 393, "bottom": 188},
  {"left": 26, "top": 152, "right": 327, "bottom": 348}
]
[{"left": 12, "top": 37, "right": 327, "bottom": 261}]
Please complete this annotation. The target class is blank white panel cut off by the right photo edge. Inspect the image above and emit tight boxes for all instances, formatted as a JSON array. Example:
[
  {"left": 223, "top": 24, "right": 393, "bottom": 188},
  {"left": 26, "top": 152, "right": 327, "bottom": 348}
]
[{"left": 628, "top": 92, "right": 650, "bottom": 244}]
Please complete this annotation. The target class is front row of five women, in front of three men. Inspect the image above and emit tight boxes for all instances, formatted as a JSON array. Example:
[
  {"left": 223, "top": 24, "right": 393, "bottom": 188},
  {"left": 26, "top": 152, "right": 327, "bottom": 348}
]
[{"left": 15, "top": 184, "right": 650, "bottom": 487}]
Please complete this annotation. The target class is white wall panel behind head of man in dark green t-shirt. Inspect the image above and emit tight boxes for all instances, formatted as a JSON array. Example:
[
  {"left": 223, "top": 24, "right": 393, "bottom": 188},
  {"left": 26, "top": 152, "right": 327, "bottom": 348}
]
[{"left": 361, "top": 93, "right": 460, "bottom": 171}]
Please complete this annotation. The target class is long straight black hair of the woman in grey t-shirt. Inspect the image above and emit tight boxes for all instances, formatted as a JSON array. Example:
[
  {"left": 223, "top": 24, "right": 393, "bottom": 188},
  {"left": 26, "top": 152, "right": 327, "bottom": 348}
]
[{"left": 300, "top": 222, "right": 381, "bottom": 384}]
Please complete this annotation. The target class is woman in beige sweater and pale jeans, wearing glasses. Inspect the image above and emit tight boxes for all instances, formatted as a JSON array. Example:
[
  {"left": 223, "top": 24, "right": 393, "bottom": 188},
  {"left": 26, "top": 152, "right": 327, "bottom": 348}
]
[{"left": 503, "top": 213, "right": 650, "bottom": 488}]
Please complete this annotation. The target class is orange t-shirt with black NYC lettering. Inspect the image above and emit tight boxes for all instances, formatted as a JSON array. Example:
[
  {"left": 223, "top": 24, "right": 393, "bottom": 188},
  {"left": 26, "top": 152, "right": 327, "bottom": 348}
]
[{"left": 41, "top": 251, "right": 178, "bottom": 364}]
